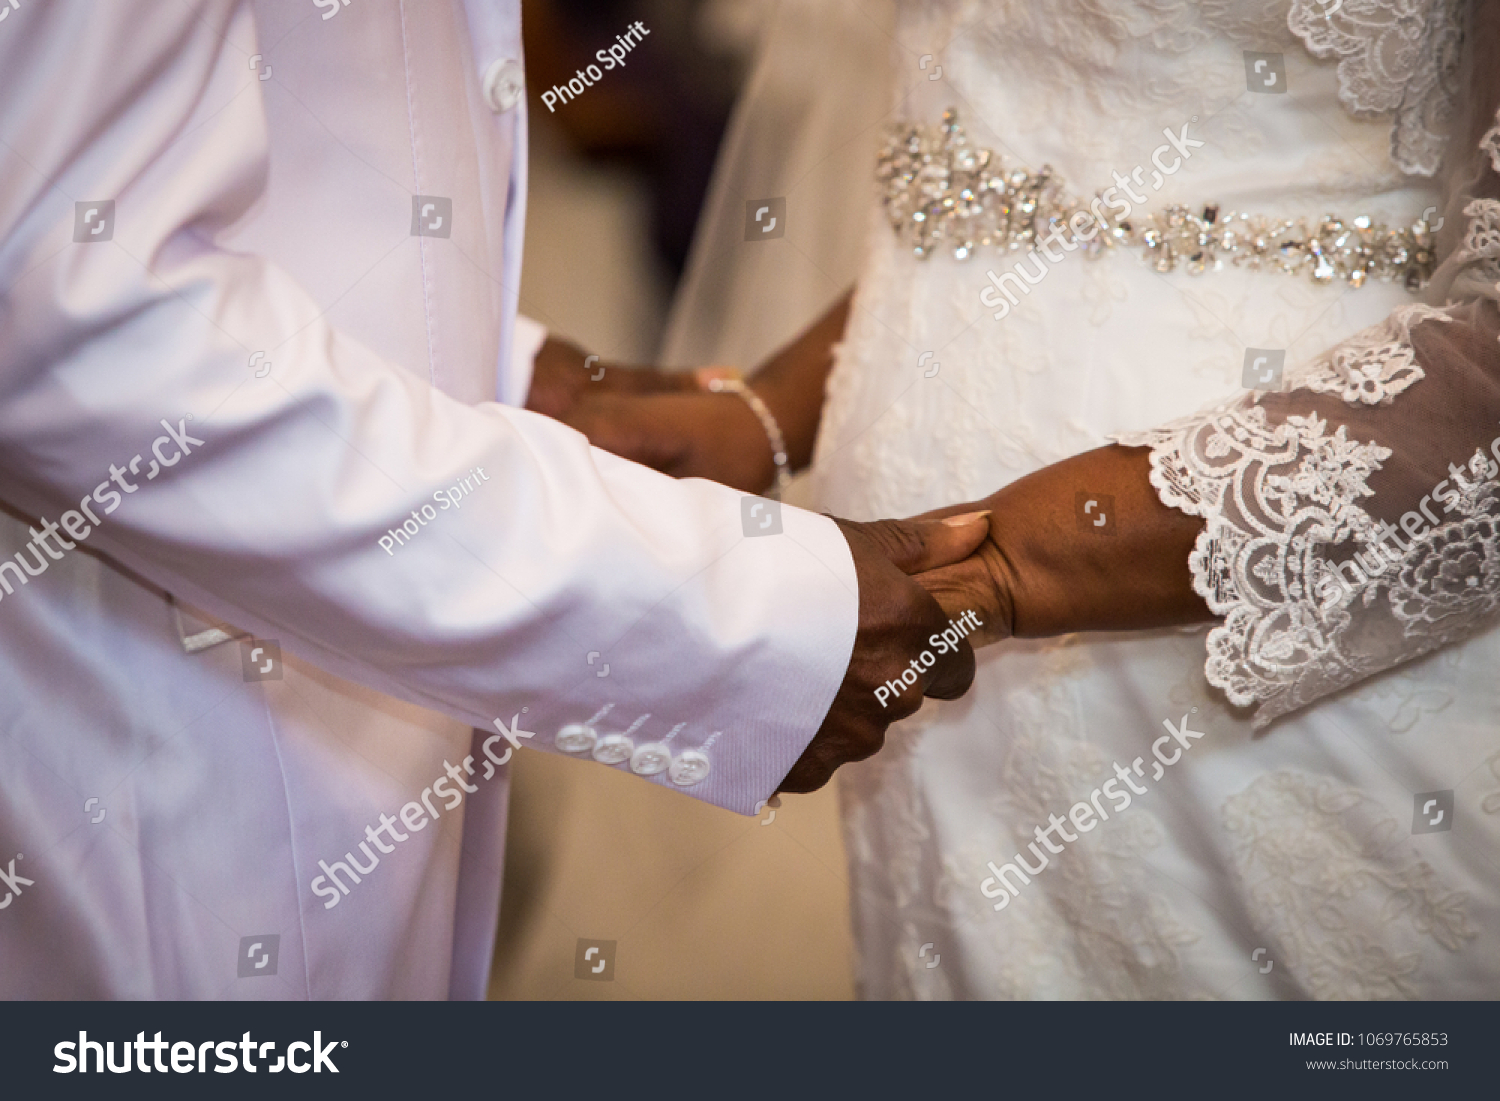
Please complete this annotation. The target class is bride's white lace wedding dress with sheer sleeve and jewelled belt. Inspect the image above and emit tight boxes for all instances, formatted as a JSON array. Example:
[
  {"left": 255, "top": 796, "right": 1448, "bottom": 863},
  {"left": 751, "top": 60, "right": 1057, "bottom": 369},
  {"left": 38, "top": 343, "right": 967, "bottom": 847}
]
[{"left": 810, "top": 0, "right": 1500, "bottom": 999}]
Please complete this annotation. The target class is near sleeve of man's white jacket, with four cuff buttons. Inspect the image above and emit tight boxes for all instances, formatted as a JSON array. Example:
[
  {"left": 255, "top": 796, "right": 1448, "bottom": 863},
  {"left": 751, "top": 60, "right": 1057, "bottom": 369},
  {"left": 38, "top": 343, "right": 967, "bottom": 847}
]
[{"left": 0, "top": 2, "right": 858, "bottom": 813}]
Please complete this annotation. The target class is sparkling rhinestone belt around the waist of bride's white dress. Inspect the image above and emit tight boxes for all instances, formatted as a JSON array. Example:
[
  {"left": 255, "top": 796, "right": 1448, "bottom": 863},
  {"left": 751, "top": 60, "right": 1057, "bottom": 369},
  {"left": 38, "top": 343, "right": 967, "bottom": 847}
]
[{"left": 876, "top": 110, "right": 1436, "bottom": 291}]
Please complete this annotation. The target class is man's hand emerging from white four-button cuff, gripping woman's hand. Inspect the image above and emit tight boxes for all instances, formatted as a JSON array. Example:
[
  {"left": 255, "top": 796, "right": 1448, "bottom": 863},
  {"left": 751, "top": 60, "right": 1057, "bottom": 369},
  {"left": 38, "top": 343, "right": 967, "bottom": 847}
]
[{"left": 780, "top": 513, "right": 990, "bottom": 792}]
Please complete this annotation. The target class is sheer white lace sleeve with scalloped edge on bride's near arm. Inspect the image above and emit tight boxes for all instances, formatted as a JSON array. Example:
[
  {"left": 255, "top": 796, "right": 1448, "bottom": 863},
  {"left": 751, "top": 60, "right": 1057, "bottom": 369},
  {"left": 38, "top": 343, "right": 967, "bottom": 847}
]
[{"left": 1118, "top": 8, "right": 1500, "bottom": 728}]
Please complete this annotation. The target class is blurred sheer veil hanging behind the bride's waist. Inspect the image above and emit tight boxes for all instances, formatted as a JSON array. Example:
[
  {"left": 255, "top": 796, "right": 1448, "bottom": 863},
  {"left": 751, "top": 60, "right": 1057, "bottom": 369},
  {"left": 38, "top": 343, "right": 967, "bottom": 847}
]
[{"left": 660, "top": 0, "right": 894, "bottom": 369}]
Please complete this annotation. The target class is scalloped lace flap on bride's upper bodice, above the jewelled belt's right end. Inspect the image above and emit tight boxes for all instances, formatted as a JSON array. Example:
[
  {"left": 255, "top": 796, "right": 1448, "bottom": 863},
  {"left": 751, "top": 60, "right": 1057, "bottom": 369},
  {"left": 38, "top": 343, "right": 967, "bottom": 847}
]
[{"left": 1287, "top": 0, "right": 1467, "bottom": 176}]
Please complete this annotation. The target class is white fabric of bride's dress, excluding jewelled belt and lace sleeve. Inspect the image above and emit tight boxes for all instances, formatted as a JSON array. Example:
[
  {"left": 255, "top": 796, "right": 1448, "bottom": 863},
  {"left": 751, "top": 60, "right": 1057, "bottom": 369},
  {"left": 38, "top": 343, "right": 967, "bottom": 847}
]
[{"left": 815, "top": 0, "right": 1500, "bottom": 998}]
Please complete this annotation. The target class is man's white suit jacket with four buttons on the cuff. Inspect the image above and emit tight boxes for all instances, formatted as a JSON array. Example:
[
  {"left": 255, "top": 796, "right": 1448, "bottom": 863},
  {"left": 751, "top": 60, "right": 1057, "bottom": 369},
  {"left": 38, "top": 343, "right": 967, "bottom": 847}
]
[{"left": 0, "top": 0, "right": 857, "bottom": 998}]
